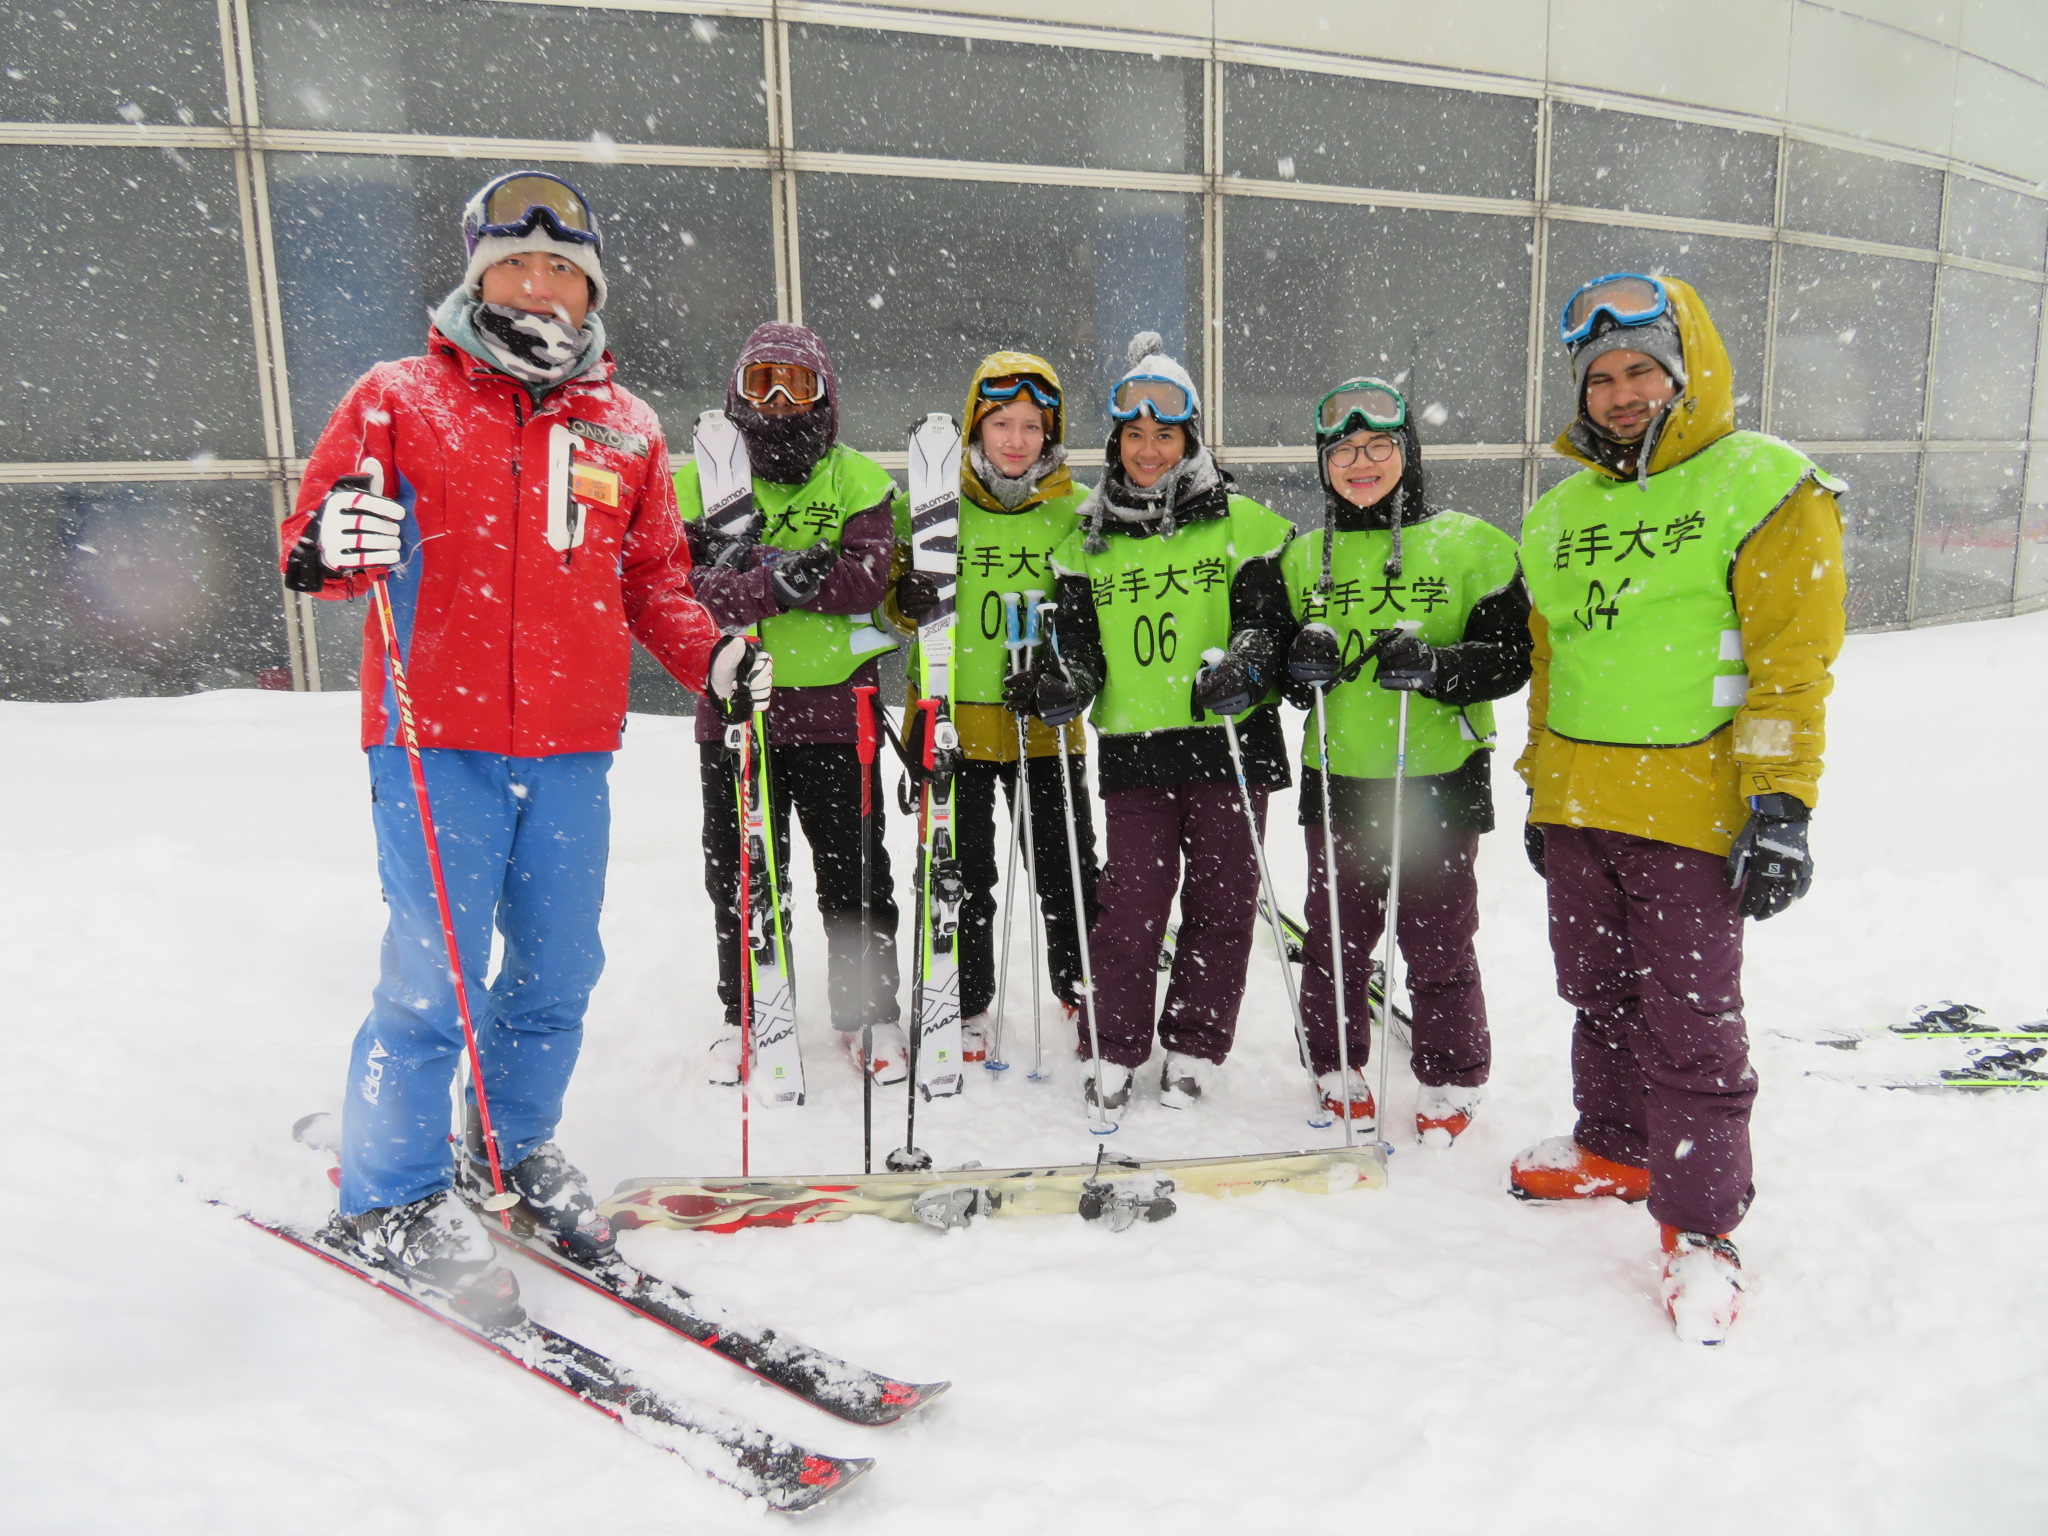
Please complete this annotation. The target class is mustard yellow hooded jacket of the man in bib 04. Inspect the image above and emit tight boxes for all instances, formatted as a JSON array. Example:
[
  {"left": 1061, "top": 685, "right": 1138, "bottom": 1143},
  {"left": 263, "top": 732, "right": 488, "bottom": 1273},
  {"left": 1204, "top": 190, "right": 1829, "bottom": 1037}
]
[{"left": 1516, "top": 279, "right": 1847, "bottom": 854}]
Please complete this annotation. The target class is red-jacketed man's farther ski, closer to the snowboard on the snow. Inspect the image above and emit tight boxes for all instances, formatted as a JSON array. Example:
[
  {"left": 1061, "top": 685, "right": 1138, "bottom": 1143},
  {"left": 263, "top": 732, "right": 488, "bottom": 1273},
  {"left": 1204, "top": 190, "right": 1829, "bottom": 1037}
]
[{"left": 293, "top": 1114, "right": 952, "bottom": 1425}]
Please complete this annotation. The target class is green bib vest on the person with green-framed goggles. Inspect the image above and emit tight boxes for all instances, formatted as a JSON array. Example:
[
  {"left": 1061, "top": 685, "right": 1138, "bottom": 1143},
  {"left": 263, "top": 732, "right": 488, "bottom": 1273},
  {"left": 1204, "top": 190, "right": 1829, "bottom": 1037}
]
[{"left": 1280, "top": 512, "right": 1516, "bottom": 778}]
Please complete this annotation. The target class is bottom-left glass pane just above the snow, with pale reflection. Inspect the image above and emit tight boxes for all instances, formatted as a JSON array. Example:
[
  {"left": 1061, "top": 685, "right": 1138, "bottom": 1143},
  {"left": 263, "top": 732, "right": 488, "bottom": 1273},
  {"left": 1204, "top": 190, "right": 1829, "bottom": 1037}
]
[{"left": 0, "top": 483, "right": 291, "bottom": 700}]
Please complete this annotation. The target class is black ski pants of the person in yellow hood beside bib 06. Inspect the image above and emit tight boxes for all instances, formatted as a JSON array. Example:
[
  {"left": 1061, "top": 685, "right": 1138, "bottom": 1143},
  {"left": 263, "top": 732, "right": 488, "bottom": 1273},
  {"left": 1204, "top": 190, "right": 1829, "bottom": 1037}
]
[{"left": 952, "top": 754, "right": 1096, "bottom": 1018}]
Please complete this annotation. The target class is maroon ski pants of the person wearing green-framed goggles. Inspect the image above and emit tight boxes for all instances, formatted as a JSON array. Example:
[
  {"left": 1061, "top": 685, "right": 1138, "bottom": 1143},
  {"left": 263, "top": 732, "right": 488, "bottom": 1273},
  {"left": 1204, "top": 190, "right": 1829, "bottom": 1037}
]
[{"left": 1300, "top": 823, "right": 1493, "bottom": 1087}]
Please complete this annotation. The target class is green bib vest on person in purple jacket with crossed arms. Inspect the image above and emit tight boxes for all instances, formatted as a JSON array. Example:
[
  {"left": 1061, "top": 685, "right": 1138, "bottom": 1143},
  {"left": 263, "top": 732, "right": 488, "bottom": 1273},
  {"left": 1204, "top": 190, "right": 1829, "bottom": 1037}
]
[{"left": 676, "top": 444, "right": 895, "bottom": 688}]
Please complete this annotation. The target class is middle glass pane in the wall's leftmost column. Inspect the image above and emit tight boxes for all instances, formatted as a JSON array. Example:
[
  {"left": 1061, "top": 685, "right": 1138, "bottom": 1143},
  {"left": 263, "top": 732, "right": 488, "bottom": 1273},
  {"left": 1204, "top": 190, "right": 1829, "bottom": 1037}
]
[{"left": 0, "top": 145, "right": 264, "bottom": 461}]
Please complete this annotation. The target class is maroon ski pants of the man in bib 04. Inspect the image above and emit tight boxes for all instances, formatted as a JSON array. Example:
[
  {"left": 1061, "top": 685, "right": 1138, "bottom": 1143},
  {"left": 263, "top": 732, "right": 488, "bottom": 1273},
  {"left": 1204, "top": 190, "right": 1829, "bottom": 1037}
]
[{"left": 1544, "top": 825, "right": 1757, "bottom": 1233}]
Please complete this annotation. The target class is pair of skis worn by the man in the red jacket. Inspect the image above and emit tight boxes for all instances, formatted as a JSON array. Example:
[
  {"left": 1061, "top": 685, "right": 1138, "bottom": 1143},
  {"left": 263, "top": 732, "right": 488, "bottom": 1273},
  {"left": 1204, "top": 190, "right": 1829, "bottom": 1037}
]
[{"left": 242, "top": 1114, "right": 948, "bottom": 1513}]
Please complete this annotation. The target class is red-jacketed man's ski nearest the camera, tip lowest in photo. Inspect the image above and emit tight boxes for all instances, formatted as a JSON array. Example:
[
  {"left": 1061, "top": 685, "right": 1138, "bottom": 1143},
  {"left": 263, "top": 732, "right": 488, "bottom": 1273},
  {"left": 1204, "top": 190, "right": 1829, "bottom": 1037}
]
[{"left": 240, "top": 1212, "right": 874, "bottom": 1513}]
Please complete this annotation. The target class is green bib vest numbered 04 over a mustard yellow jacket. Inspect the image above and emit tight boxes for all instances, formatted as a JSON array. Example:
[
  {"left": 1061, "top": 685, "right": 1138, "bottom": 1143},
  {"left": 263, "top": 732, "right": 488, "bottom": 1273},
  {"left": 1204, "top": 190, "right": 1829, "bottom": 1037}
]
[{"left": 1522, "top": 432, "right": 1839, "bottom": 748}]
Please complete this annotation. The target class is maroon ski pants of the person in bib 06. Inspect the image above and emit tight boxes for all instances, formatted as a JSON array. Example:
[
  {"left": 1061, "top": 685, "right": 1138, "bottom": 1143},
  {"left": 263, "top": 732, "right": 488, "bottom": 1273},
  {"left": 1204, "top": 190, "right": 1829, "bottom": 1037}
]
[{"left": 1081, "top": 784, "right": 1266, "bottom": 1069}]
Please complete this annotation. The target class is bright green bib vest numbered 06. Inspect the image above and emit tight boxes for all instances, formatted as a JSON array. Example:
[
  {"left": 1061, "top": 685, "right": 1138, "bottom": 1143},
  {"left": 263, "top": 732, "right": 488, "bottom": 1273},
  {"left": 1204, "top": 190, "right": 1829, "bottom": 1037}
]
[{"left": 1053, "top": 496, "right": 1294, "bottom": 735}]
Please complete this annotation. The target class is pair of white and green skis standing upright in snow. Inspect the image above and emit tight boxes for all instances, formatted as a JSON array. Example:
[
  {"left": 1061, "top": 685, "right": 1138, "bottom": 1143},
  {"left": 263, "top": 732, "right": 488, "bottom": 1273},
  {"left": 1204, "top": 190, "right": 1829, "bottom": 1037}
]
[{"left": 692, "top": 412, "right": 967, "bottom": 1130}]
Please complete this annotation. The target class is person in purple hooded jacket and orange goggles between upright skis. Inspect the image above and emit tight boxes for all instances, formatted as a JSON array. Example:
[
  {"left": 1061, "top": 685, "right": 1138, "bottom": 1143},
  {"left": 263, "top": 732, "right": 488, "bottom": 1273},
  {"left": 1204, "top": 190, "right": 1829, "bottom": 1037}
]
[{"left": 676, "top": 322, "right": 907, "bottom": 1083}]
